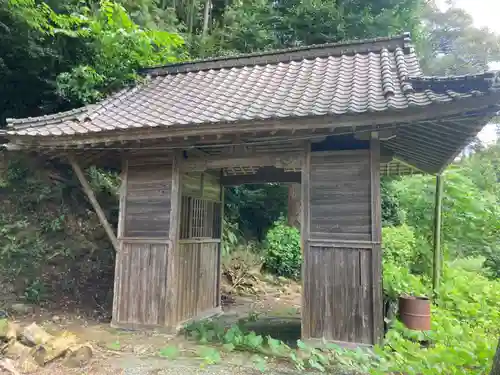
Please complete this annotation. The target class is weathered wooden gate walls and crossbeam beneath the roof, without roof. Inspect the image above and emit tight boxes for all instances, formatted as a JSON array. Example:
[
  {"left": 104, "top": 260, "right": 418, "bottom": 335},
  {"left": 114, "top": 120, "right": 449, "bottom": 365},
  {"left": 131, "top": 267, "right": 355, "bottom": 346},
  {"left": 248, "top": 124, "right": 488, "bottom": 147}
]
[{"left": 108, "top": 139, "right": 382, "bottom": 344}]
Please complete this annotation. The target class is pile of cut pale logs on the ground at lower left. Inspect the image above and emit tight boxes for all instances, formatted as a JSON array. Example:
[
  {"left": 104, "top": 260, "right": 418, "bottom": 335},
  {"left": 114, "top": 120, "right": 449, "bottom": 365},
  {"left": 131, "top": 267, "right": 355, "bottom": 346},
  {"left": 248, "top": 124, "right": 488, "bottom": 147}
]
[{"left": 0, "top": 319, "right": 92, "bottom": 374}]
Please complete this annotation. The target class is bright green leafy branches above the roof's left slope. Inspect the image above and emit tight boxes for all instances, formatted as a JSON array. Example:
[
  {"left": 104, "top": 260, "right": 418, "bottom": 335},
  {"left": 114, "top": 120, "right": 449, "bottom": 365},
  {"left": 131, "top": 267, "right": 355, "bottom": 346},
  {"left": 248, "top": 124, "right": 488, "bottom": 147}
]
[{"left": 11, "top": 0, "right": 183, "bottom": 104}]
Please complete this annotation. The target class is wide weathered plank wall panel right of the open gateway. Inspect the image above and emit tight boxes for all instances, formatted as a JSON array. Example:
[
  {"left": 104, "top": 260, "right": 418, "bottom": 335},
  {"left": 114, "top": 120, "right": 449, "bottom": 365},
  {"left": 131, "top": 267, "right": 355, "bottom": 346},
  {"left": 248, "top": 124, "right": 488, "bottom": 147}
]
[{"left": 302, "top": 145, "right": 383, "bottom": 345}]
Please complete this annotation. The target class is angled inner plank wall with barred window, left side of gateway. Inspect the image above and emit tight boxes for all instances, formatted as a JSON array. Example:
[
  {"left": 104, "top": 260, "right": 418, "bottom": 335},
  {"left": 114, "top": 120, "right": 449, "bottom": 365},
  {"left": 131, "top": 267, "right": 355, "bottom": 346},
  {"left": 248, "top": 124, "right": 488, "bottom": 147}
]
[{"left": 174, "top": 172, "right": 222, "bottom": 323}]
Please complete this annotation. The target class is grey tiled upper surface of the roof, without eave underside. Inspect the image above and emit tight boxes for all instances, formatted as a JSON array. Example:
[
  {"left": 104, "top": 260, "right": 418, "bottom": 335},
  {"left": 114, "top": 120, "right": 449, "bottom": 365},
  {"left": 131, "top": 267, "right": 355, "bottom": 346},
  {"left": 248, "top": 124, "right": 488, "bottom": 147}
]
[{"left": 8, "top": 35, "right": 496, "bottom": 137}]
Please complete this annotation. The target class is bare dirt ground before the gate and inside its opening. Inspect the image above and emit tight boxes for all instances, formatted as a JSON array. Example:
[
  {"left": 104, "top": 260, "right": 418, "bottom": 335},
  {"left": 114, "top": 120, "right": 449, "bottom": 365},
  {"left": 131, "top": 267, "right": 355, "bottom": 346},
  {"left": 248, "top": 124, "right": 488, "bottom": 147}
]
[{"left": 5, "top": 283, "right": 306, "bottom": 375}]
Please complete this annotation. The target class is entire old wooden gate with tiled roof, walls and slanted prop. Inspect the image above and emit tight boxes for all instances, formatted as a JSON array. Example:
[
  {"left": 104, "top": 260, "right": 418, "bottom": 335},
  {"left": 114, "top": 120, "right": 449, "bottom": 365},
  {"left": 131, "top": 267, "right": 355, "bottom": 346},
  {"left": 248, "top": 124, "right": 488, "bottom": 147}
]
[{"left": 0, "top": 34, "right": 500, "bottom": 345}]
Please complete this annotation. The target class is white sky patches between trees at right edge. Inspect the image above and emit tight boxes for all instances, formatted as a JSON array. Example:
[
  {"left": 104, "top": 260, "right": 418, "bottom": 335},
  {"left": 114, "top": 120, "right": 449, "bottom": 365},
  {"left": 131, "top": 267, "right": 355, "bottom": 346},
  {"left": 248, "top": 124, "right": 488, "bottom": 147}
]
[{"left": 436, "top": 0, "right": 500, "bottom": 143}]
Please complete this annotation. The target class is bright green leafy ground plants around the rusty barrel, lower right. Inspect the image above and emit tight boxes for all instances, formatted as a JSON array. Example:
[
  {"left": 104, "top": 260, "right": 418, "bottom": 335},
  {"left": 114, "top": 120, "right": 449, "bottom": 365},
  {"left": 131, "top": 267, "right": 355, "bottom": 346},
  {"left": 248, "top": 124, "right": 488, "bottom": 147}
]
[{"left": 372, "top": 263, "right": 500, "bottom": 375}]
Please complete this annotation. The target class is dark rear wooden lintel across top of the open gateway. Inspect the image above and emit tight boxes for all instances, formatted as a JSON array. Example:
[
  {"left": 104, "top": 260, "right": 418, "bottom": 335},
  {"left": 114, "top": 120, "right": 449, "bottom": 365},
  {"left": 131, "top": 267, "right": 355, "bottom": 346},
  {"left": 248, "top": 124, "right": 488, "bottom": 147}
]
[{"left": 221, "top": 167, "right": 301, "bottom": 186}]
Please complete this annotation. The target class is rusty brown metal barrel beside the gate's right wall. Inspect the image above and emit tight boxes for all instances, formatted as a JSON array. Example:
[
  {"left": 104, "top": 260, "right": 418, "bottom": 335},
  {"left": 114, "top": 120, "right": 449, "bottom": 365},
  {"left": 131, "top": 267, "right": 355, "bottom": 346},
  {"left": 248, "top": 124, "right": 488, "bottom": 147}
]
[{"left": 399, "top": 296, "right": 431, "bottom": 331}]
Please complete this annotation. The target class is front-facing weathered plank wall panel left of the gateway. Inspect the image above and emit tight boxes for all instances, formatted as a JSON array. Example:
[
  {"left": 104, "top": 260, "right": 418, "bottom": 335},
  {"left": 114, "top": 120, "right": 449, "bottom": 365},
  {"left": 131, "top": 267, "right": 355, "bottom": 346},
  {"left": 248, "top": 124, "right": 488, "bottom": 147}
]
[{"left": 112, "top": 158, "right": 172, "bottom": 328}]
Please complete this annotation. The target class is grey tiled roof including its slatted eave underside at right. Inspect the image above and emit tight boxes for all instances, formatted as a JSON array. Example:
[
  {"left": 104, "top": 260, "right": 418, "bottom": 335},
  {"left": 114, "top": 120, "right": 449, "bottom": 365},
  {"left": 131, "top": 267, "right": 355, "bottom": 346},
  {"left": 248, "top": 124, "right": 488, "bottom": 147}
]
[{"left": 0, "top": 34, "right": 500, "bottom": 173}]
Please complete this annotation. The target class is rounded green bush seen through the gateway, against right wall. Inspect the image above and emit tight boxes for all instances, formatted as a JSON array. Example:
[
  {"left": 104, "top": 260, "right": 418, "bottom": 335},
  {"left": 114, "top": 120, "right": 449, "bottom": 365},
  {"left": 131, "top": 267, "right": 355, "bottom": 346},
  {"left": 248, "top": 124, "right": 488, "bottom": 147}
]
[{"left": 264, "top": 220, "right": 302, "bottom": 278}]
